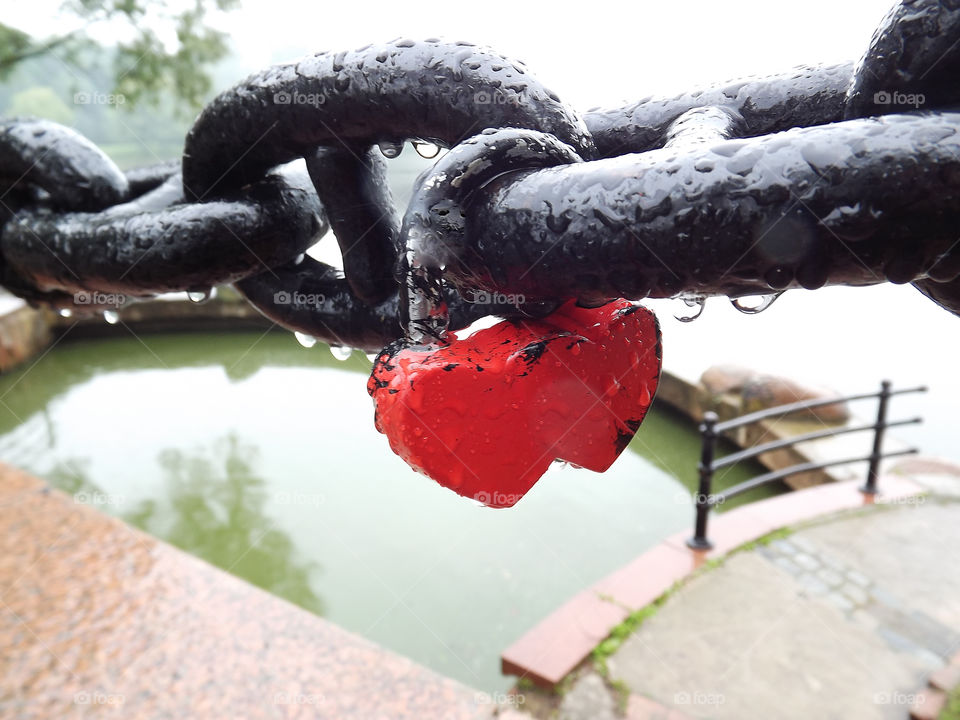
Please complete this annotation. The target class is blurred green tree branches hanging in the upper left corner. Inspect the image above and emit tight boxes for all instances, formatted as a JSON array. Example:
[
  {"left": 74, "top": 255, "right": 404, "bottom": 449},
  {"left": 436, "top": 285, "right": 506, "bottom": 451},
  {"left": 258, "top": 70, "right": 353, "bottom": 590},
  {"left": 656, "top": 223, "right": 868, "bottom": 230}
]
[{"left": 0, "top": 0, "right": 239, "bottom": 110}]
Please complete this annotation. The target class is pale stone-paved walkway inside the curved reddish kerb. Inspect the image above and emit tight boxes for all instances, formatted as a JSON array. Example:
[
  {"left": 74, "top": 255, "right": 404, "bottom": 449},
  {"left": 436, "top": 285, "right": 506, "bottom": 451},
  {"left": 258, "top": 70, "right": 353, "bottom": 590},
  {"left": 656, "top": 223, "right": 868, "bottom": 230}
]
[{"left": 525, "top": 464, "right": 960, "bottom": 720}]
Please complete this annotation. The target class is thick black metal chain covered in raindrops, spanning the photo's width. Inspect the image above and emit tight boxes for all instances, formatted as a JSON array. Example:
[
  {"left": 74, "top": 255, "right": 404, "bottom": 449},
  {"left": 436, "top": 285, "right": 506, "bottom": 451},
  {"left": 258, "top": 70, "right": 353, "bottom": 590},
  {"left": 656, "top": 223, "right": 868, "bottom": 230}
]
[{"left": 0, "top": 0, "right": 960, "bottom": 350}]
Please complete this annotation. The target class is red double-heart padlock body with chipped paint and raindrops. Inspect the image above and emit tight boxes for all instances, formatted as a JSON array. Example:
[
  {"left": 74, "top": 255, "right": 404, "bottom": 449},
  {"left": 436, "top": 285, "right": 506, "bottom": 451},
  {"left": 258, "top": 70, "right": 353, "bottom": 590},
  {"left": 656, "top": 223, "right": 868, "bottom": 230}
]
[{"left": 367, "top": 300, "right": 661, "bottom": 507}]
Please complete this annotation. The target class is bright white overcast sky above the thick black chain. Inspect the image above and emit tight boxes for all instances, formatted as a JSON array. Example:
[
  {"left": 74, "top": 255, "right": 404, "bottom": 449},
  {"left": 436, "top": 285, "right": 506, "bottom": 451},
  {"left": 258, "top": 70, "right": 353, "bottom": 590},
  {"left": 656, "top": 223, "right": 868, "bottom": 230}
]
[{"left": 7, "top": 0, "right": 893, "bottom": 109}]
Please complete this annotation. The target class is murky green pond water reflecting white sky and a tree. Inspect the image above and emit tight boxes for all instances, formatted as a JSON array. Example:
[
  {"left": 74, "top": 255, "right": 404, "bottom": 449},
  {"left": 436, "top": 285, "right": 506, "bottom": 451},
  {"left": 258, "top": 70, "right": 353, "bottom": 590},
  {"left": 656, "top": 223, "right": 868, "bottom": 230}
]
[{"left": 0, "top": 327, "right": 770, "bottom": 691}]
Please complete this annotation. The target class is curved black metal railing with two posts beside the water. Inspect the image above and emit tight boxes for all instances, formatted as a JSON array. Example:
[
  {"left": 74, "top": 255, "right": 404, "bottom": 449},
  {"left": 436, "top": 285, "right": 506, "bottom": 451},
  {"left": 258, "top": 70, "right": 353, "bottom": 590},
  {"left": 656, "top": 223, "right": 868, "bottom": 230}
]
[{"left": 687, "top": 380, "right": 927, "bottom": 550}]
